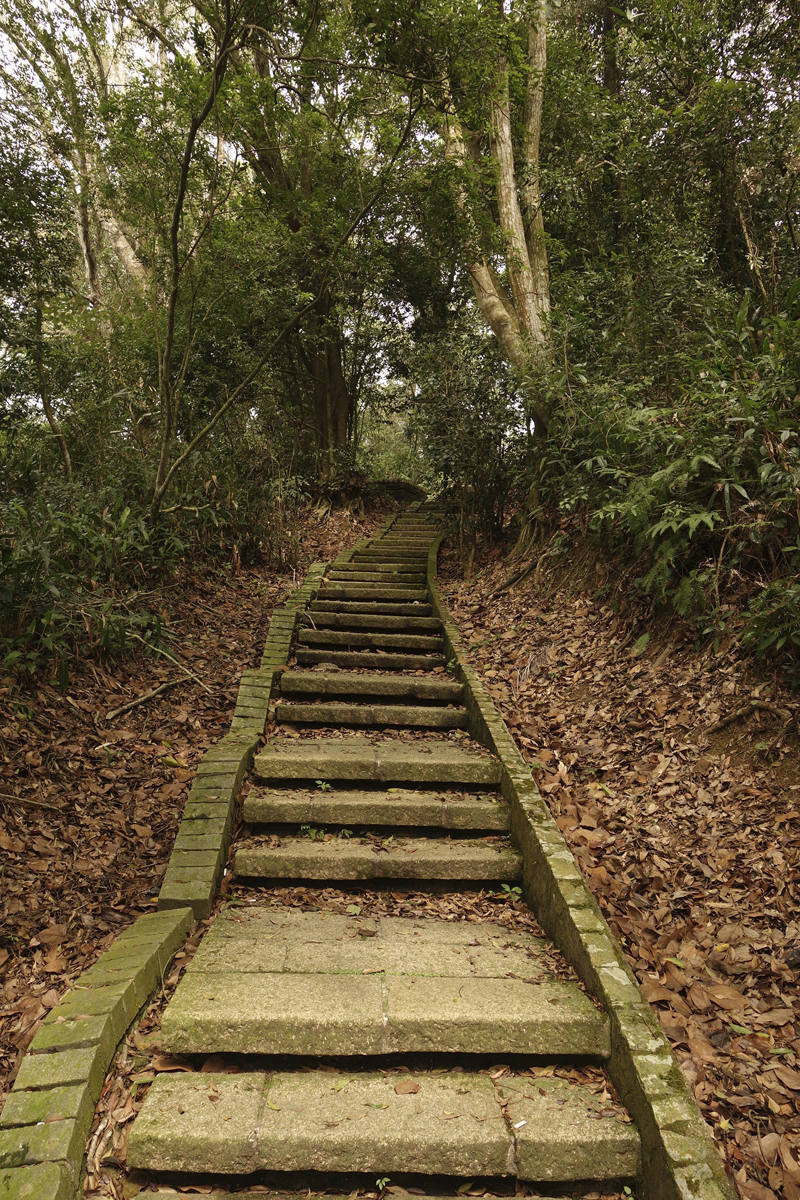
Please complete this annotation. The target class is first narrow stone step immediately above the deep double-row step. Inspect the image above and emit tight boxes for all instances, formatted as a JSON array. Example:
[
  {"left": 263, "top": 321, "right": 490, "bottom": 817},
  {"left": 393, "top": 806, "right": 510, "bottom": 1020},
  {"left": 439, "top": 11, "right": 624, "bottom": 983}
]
[{"left": 234, "top": 838, "right": 522, "bottom": 883}]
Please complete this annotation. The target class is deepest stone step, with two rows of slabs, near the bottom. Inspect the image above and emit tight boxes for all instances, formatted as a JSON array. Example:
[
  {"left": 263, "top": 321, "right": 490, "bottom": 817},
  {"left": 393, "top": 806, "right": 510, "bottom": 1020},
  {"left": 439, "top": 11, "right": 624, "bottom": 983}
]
[{"left": 155, "top": 905, "right": 610, "bottom": 1060}]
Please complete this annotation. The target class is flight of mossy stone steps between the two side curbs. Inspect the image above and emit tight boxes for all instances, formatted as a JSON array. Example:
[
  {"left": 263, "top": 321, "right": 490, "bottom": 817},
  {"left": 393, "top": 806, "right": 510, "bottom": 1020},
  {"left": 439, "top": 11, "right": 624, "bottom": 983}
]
[{"left": 128, "top": 506, "right": 642, "bottom": 1194}]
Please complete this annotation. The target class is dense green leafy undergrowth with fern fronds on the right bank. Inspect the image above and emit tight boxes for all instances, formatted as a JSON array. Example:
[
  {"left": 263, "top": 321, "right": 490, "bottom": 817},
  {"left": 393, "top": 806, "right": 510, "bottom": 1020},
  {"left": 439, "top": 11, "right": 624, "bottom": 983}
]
[{"left": 527, "top": 283, "right": 800, "bottom": 665}]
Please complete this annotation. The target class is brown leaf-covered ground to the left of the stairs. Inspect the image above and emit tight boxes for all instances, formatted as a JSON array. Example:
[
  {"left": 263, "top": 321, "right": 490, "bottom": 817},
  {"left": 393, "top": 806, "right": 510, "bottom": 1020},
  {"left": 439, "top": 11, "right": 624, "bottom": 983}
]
[{"left": 0, "top": 503, "right": 395, "bottom": 1109}]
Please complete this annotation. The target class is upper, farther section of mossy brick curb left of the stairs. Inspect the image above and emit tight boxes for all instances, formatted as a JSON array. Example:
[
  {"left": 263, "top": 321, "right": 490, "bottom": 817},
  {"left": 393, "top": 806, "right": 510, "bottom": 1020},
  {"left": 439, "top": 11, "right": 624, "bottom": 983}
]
[{"left": 158, "top": 563, "right": 327, "bottom": 920}]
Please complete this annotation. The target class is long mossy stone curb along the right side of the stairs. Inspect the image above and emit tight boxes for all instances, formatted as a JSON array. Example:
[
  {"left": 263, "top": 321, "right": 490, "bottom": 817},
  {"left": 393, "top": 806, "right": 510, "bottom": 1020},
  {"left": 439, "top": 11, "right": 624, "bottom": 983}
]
[{"left": 427, "top": 539, "right": 736, "bottom": 1200}]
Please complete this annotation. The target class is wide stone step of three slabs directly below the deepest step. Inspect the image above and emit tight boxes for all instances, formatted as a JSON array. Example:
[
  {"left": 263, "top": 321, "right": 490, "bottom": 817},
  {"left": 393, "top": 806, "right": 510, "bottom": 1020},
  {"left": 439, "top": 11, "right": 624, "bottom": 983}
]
[{"left": 127, "top": 1070, "right": 640, "bottom": 1183}]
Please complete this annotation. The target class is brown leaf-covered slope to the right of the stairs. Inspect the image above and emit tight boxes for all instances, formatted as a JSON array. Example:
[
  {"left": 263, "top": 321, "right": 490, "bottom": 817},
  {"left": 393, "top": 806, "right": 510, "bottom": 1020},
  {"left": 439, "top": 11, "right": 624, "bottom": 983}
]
[{"left": 440, "top": 542, "right": 800, "bottom": 1200}]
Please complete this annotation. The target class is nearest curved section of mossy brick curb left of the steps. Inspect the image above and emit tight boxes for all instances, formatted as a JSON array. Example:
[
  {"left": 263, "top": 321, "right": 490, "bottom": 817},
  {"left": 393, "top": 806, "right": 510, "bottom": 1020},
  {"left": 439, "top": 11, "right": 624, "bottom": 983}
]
[{"left": 0, "top": 908, "right": 192, "bottom": 1200}]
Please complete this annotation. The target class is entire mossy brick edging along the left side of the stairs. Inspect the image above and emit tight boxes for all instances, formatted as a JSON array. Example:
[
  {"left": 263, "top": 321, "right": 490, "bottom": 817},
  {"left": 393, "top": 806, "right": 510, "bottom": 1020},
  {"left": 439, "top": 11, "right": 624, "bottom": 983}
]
[{"left": 0, "top": 563, "right": 327, "bottom": 1200}]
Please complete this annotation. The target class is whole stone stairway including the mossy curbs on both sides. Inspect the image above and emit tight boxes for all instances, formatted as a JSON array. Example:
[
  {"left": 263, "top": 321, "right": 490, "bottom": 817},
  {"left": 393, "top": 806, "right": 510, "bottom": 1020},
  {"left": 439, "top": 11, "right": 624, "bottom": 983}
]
[{"left": 0, "top": 504, "right": 732, "bottom": 1200}]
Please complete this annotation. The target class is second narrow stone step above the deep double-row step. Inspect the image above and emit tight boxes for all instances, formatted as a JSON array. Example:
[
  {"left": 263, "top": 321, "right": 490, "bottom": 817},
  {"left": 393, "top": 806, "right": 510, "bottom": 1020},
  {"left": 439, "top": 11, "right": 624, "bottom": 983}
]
[{"left": 242, "top": 787, "right": 510, "bottom": 833}]
